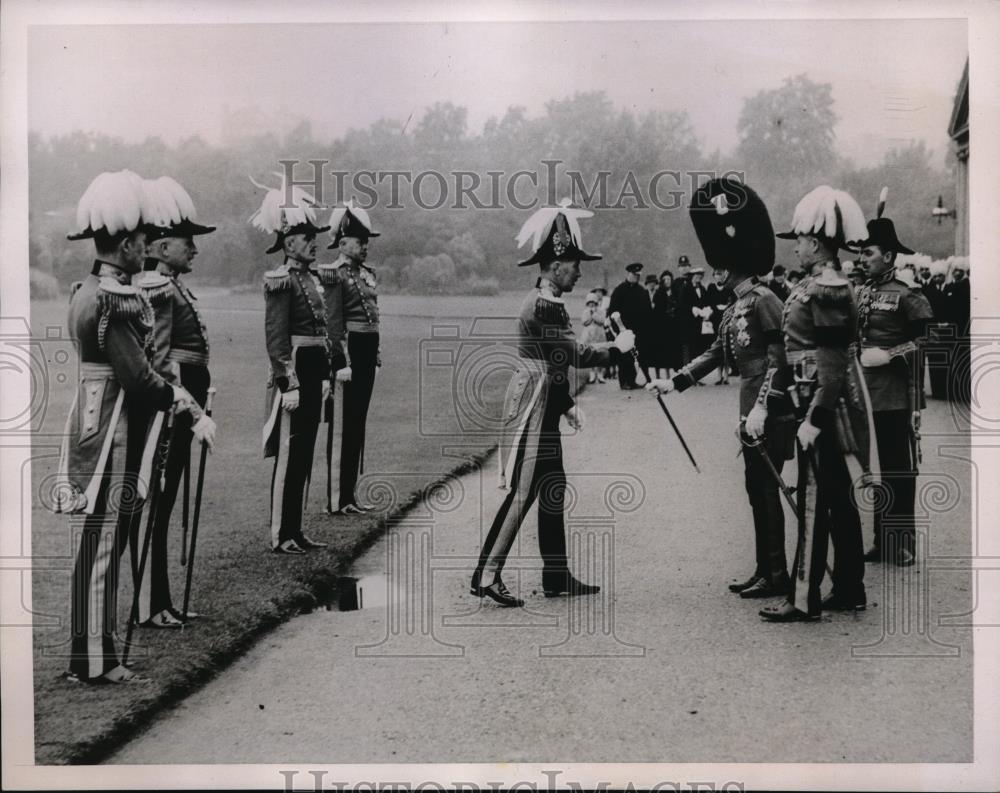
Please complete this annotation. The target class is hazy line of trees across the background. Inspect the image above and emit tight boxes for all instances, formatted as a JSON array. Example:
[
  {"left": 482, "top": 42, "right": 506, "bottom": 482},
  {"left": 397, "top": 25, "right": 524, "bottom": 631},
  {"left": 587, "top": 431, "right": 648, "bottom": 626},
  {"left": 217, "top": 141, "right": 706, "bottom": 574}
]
[{"left": 29, "top": 75, "right": 955, "bottom": 294}]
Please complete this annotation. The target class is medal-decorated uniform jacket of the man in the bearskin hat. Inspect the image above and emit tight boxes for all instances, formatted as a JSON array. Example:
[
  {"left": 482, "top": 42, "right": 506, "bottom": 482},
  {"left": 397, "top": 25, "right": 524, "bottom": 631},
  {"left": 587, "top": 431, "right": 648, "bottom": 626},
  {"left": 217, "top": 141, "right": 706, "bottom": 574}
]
[{"left": 673, "top": 279, "right": 792, "bottom": 418}]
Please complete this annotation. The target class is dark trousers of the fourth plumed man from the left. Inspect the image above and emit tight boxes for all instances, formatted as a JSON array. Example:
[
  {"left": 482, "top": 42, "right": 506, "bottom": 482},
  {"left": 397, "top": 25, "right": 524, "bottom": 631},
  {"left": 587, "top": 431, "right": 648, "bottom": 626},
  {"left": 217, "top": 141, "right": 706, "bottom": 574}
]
[{"left": 338, "top": 333, "right": 379, "bottom": 508}]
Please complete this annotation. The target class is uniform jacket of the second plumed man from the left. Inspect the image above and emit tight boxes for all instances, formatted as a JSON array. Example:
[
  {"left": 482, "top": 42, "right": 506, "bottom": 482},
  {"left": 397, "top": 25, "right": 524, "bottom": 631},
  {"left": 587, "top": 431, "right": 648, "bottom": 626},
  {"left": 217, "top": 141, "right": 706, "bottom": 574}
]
[{"left": 134, "top": 271, "right": 208, "bottom": 378}]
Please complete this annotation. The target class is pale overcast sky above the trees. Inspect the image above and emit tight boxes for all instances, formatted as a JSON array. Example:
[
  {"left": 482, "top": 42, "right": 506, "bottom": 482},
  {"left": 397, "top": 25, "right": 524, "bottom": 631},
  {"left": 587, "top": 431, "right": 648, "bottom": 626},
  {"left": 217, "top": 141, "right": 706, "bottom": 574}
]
[{"left": 28, "top": 20, "right": 967, "bottom": 165}]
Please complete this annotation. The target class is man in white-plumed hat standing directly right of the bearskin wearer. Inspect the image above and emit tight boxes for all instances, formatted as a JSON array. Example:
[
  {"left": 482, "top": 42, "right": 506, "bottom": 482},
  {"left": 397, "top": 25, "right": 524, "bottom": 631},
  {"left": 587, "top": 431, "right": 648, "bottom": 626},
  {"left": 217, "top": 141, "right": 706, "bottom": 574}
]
[{"left": 760, "top": 185, "right": 874, "bottom": 622}]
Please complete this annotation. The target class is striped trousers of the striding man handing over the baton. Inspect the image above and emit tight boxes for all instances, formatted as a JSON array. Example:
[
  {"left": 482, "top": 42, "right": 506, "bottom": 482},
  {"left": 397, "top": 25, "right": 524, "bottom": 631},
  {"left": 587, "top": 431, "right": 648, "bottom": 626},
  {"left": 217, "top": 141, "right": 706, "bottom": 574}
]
[{"left": 473, "top": 406, "right": 569, "bottom": 586}]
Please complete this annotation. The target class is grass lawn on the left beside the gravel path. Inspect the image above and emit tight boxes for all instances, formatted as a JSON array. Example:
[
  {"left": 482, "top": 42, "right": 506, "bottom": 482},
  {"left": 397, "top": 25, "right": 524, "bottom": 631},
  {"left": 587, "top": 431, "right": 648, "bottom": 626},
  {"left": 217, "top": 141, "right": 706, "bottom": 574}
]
[{"left": 31, "top": 287, "right": 596, "bottom": 764}]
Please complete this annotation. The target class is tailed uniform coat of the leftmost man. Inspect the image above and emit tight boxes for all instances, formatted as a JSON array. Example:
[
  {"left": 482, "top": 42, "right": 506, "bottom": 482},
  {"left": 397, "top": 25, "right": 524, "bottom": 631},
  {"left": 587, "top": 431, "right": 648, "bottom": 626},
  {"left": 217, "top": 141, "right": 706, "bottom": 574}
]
[{"left": 54, "top": 266, "right": 173, "bottom": 514}]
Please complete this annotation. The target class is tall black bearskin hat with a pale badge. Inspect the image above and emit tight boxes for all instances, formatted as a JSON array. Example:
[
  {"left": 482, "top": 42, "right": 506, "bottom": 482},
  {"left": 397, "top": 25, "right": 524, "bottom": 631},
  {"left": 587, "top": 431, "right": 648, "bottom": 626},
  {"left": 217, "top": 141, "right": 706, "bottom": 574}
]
[{"left": 689, "top": 177, "right": 774, "bottom": 275}]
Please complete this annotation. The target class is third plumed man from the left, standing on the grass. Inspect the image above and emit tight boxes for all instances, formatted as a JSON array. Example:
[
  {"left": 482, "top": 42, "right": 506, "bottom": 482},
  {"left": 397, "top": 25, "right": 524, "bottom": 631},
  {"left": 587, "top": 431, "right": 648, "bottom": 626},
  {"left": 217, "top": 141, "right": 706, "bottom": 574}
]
[{"left": 250, "top": 177, "right": 330, "bottom": 555}]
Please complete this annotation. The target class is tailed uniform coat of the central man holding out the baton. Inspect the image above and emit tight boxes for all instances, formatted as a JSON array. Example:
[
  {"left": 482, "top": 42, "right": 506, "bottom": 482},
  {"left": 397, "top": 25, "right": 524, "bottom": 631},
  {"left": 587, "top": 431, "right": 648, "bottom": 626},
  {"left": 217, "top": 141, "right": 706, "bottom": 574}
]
[{"left": 499, "top": 287, "right": 618, "bottom": 488}]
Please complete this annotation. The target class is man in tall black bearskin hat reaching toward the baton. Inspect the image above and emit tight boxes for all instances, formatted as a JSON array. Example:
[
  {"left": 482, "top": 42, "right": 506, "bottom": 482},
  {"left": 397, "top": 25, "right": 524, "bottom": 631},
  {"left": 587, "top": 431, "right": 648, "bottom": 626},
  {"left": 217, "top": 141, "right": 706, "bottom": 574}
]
[{"left": 649, "top": 177, "right": 795, "bottom": 598}]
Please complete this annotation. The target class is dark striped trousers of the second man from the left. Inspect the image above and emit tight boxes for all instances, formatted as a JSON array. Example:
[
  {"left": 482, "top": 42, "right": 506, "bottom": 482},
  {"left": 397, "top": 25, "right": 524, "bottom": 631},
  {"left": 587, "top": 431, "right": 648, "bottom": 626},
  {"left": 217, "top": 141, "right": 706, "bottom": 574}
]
[{"left": 139, "top": 363, "right": 212, "bottom": 622}]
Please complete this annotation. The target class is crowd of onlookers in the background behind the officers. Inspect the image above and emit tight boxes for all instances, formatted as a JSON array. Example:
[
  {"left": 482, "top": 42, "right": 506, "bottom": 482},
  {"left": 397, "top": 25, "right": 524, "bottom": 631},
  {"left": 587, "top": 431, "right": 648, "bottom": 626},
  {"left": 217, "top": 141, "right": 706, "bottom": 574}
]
[{"left": 582, "top": 254, "right": 971, "bottom": 399}]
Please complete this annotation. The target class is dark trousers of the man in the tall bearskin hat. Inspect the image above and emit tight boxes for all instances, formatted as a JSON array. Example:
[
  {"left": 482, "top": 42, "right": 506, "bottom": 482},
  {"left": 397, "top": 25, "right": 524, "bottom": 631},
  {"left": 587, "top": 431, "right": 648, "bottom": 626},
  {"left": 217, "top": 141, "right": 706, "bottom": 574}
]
[{"left": 743, "top": 419, "right": 795, "bottom": 584}]
